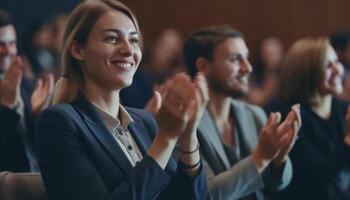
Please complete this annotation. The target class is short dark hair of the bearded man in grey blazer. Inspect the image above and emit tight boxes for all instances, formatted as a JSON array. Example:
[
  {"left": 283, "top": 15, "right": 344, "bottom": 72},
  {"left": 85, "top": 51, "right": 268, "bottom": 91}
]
[{"left": 183, "top": 25, "right": 244, "bottom": 77}]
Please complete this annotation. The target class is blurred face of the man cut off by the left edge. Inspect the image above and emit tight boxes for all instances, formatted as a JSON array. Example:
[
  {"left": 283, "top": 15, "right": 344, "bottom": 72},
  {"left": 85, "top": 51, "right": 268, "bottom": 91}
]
[{"left": 0, "top": 25, "right": 17, "bottom": 73}]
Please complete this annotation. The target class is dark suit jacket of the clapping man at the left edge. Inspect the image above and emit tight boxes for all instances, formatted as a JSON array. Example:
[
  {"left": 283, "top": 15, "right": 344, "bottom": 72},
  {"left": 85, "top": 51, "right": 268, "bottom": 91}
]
[{"left": 0, "top": 78, "right": 35, "bottom": 172}]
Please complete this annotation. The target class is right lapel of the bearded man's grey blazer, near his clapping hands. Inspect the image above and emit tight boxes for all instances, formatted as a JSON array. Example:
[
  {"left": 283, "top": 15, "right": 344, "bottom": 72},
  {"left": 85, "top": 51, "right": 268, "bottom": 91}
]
[{"left": 232, "top": 100, "right": 258, "bottom": 156}]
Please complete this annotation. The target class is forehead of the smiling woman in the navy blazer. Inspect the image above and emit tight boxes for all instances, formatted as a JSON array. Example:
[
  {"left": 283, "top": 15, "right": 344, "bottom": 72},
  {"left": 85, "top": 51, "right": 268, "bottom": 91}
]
[{"left": 92, "top": 10, "right": 136, "bottom": 33}]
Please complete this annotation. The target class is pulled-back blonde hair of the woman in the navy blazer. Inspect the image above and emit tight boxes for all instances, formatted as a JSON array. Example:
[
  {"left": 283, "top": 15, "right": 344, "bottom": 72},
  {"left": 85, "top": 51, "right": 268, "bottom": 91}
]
[{"left": 52, "top": 0, "right": 141, "bottom": 104}]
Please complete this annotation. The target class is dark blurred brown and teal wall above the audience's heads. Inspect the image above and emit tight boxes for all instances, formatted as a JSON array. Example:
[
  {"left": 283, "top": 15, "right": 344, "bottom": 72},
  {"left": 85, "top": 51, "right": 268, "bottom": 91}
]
[{"left": 0, "top": 0, "right": 350, "bottom": 52}]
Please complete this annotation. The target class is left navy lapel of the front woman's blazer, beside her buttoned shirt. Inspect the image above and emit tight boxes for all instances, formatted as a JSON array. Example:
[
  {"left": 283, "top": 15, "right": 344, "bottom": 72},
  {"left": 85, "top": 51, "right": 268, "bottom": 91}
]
[{"left": 72, "top": 95, "right": 132, "bottom": 174}]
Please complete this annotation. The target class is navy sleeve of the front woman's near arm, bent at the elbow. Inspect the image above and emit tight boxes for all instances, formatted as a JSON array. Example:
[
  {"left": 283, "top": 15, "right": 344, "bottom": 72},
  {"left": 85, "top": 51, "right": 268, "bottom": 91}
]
[{"left": 35, "top": 107, "right": 175, "bottom": 200}]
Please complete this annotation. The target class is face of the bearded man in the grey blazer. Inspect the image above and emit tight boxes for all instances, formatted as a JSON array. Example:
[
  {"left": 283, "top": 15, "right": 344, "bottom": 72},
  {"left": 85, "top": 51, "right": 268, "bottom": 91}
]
[{"left": 207, "top": 38, "right": 252, "bottom": 97}]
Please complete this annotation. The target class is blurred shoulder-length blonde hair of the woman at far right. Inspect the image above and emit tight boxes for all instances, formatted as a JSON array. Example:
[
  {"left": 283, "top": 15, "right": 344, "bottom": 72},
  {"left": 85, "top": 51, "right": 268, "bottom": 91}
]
[{"left": 281, "top": 37, "right": 330, "bottom": 106}]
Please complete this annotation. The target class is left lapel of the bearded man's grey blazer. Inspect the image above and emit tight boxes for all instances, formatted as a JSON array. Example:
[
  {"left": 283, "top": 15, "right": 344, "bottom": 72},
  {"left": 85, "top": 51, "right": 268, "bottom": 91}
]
[{"left": 198, "top": 110, "right": 230, "bottom": 169}]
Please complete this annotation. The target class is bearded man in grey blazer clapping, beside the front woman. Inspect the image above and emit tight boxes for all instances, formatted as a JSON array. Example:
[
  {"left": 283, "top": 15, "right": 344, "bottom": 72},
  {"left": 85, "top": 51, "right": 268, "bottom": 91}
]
[{"left": 184, "top": 26, "right": 301, "bottom": 200}]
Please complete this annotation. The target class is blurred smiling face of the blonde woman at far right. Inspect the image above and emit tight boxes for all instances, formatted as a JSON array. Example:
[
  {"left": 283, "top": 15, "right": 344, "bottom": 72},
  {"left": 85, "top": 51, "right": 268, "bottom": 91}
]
[{"left": 320, "top": 46, "right": 344, "bottom": 95}]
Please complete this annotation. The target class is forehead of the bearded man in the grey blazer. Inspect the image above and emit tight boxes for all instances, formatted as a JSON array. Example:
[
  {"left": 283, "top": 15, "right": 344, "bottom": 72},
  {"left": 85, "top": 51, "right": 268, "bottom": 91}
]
[{"left": 215, "top": 37, "right": 248, "bottom": 54}]
